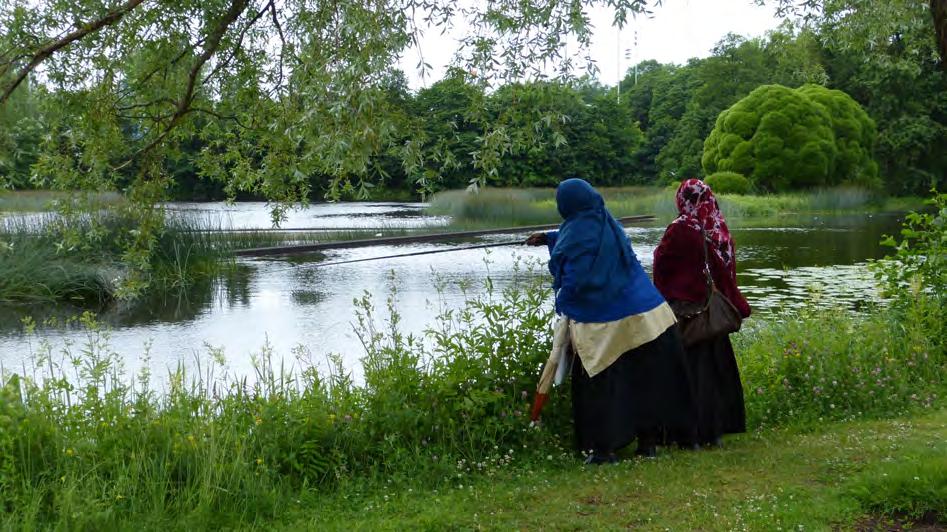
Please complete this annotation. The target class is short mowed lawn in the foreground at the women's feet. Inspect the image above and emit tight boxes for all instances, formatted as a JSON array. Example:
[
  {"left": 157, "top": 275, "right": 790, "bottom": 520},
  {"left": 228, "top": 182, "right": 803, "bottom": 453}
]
[{"left": 281, "top": 410, "right": 947, "bottom": 530}]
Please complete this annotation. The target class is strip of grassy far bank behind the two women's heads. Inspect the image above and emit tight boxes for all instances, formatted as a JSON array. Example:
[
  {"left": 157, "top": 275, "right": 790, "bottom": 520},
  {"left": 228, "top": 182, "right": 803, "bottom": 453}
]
[{"left": 429, "top": 187, "right": 923, "bottom": 226}]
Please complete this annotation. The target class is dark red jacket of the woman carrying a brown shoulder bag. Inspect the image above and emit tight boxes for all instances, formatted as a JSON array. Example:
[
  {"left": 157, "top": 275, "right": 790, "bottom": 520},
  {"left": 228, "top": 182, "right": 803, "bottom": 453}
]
[{"left": 654, "top": 223, "right": 750, "bottom": 318}]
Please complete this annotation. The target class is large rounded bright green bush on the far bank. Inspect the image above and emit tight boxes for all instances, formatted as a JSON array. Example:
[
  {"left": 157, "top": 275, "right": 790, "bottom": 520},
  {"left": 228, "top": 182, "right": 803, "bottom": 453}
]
[{"left": 701, "top": 85, "right": 878, "bottom": 191}]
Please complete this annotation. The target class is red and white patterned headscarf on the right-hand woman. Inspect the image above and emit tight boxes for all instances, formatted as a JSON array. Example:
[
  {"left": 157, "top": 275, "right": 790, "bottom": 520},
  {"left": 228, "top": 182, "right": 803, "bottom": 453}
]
[{"left": 673, "top": 179, "right": 734, "bottom": 269}]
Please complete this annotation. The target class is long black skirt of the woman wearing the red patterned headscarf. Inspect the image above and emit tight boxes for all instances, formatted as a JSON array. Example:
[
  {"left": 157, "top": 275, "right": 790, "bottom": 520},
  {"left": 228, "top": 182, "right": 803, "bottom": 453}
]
[{"left": 686, "top": 334, "right": 746, "bottom": 444}]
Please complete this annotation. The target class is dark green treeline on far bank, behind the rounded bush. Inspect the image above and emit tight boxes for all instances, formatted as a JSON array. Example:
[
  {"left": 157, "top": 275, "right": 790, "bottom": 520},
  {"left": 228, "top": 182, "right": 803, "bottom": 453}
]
[{"left": 0, "top": 20, "right": 947, "bottom": 199}]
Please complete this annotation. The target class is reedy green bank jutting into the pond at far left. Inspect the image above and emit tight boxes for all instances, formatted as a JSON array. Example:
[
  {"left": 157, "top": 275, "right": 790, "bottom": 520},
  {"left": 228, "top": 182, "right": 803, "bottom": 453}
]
[{"left": 0, "top": 206, "right": 416, "bottom": 309}]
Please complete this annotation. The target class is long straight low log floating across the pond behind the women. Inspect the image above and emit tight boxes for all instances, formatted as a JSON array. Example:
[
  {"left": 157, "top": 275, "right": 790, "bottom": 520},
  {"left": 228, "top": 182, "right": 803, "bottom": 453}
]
[{"left": 234, "top": 214, "right": 655, "bottom": 257}]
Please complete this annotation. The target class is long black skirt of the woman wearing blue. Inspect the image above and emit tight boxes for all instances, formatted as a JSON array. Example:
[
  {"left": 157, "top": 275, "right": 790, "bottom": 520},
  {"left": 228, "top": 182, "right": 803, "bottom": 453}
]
[{"left": 572, "top": 326, "right": 696, "bottom": 452}]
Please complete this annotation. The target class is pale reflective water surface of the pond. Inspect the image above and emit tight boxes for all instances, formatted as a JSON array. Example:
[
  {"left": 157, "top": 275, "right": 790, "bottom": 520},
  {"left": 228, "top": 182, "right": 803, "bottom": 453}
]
[{"left": 0, "top": 203, "right": 900, "bottom": 378}]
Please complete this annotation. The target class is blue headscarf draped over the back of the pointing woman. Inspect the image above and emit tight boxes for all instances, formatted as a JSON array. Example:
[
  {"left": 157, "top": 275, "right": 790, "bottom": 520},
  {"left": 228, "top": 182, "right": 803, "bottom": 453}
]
[{"left": 549, "top": 179, "right": 664, "bottom": 322}]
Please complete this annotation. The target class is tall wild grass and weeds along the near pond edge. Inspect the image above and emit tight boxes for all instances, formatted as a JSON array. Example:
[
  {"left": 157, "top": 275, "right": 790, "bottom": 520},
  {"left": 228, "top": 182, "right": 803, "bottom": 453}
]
[{"left": 0, "top": 255, "right": 947, "bottom": 529}]
